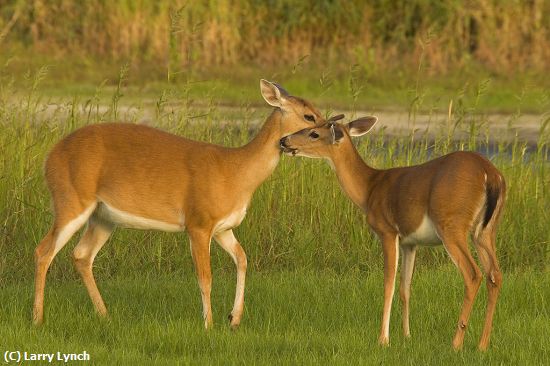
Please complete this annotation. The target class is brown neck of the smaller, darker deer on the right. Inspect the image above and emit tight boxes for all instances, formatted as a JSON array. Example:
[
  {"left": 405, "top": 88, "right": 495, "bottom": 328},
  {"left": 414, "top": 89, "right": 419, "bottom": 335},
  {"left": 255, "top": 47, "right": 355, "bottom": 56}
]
[{"left": 329, "top": 139, "right": 377, "bottom": 208}]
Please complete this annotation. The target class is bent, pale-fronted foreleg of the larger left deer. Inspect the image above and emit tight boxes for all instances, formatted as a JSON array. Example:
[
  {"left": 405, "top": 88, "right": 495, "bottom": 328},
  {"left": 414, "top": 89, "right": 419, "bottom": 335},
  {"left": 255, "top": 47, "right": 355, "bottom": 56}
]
[{"left": 214, "top": 230, "right": 247, "bottom": 329}]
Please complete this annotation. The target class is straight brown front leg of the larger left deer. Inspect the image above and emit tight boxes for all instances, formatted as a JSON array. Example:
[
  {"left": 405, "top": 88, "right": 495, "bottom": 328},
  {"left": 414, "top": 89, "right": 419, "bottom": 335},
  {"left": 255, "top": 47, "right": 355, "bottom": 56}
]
[{"left": 189, "top": 230, "right": 213, "bottom": 329}]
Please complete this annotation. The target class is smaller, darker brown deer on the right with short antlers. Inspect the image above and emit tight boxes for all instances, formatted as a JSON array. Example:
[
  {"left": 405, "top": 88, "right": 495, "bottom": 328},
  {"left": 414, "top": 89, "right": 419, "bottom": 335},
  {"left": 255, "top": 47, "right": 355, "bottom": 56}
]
[{"left": 281, "top": 117, "right": 506, "bottom": 350}]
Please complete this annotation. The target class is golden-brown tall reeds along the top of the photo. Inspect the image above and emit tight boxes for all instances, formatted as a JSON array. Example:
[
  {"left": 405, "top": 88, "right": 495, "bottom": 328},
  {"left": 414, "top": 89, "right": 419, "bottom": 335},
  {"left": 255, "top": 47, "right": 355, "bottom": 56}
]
[{"left": 0, "top": 0, "right": 550, "bottom": 75}]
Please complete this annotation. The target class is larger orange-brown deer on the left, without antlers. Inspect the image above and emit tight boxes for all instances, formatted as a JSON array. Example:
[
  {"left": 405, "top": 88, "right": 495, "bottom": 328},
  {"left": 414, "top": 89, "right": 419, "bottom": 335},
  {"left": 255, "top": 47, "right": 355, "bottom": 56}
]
[{"left": 33, "top": 80, "right": 325, "bottom": 328}]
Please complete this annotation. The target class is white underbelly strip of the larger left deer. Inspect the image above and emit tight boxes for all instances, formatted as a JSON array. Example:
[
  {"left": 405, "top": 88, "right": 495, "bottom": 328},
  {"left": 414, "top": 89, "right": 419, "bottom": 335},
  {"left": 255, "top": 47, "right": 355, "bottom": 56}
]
[{"left": 96, "top": 202, "right": 185, "bottom": 232}]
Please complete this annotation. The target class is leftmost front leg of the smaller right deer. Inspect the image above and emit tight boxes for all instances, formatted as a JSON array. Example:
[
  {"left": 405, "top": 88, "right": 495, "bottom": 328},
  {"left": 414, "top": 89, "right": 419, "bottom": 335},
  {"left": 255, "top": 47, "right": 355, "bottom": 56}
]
[{"left": 378, "top": 234, "right": 399, "bottom": 346}]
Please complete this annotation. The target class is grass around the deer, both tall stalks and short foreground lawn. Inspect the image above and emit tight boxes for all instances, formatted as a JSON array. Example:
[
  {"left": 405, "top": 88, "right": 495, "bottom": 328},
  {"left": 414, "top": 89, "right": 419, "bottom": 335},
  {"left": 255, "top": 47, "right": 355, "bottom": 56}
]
[{"left": 0, "top": 65, "right": 550, "bottom": 364}]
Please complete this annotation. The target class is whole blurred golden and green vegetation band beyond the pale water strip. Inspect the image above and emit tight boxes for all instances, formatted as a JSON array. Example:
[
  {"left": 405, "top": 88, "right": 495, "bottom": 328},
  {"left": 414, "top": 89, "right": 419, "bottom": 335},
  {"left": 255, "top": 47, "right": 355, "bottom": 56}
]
[{"left": 0, "top": 0, "right": 550, "bottom": 113}]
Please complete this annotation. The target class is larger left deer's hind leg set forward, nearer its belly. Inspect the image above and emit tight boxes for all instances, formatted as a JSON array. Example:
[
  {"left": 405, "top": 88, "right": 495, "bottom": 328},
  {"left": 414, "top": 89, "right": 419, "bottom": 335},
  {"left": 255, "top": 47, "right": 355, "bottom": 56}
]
[{"left": 73, "top": 216, "right": 113, "bottom": 316}]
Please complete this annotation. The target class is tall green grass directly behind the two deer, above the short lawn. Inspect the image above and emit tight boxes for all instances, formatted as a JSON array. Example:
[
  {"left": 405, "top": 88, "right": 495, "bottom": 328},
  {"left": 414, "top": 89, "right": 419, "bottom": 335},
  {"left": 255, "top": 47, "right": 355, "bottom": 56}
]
[{"left": 0, "top": 69, "right": 550, "bottom": 281}]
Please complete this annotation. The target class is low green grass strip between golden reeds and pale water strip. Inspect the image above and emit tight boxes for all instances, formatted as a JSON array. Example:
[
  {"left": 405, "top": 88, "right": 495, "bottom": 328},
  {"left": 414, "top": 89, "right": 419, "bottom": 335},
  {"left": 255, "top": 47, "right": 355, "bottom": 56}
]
[{"left": 0, "top": 55, "right": 550, "bottom": 113}]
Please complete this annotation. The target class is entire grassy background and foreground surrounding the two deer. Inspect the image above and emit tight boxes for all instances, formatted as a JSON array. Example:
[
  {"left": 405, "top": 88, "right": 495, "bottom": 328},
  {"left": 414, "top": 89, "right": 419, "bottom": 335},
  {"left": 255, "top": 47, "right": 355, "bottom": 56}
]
[{"left": 0, "top": 0, "right": 550, "bottom": 364}]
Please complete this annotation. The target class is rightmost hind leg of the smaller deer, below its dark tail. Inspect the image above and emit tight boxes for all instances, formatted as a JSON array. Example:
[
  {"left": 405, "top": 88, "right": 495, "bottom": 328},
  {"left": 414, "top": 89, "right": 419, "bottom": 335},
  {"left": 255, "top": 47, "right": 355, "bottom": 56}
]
[{"left": 474, "top": 228, "right": 502, "bottom": 351}]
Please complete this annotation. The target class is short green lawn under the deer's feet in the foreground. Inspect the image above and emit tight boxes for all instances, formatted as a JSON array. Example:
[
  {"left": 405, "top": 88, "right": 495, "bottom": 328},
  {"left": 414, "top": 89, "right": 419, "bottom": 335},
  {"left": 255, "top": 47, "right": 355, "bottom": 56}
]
[{"left": 0, "top": 265, "right": 550, "bottom": 365}]
